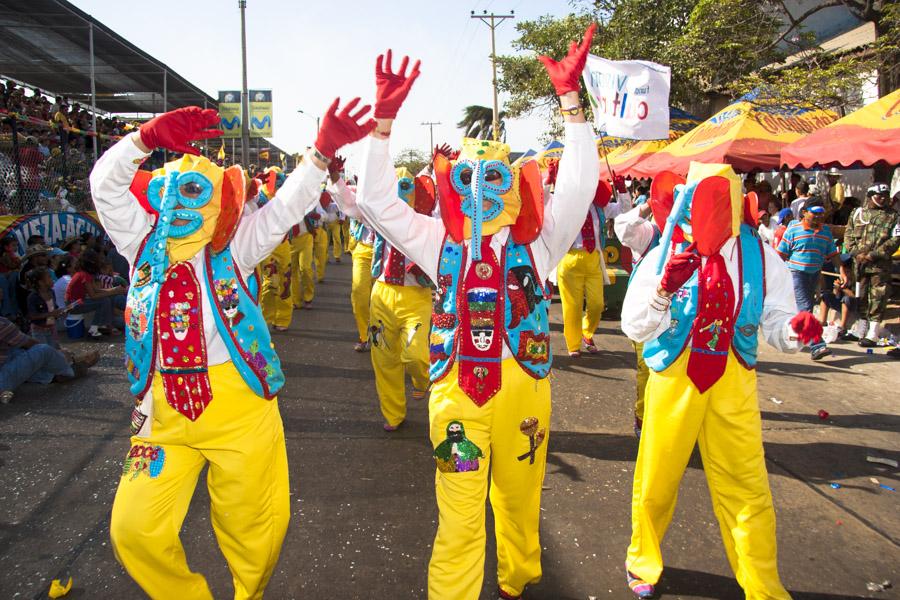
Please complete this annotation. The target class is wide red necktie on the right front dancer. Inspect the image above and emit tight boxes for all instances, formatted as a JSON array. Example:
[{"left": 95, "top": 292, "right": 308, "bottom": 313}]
[{"left": 687, "top": 253, "right": 734, "bottom": 394}]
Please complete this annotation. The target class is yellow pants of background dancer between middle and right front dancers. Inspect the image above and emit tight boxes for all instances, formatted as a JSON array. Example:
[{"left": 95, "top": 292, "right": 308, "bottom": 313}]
[{"left": 556, "top": 250, "right": 603, "bottom": 352}]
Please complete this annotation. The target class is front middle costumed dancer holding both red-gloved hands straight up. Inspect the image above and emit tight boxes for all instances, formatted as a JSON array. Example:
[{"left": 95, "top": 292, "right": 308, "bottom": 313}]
[{"left": 357, "top": 25, "right": 599, "bottom": 600}]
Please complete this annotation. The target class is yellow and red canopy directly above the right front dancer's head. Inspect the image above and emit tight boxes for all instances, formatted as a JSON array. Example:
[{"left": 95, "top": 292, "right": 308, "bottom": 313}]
[{"left": 631, "top": 94, "right": 837, "bottom": 177}]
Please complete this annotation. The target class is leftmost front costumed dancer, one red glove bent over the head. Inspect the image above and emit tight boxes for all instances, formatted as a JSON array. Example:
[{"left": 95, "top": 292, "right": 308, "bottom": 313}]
[{"left": 96, "top": 99, "right": 375, "bottom": 600}]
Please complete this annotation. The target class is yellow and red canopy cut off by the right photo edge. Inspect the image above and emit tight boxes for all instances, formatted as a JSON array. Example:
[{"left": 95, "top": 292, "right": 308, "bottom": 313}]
[{"left": 781, "top": 89, "right": 900, "bottom": 169}]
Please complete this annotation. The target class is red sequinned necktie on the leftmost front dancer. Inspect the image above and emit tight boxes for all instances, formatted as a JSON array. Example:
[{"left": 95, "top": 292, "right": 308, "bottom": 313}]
[{"left": 156, "top": 263, "right": 212, "bottom": 421}]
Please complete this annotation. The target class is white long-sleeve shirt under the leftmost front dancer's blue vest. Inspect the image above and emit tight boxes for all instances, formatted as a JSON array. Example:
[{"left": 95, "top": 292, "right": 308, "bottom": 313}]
[{"left": 90, "top": 134, "right": 325, "bottom": 365}]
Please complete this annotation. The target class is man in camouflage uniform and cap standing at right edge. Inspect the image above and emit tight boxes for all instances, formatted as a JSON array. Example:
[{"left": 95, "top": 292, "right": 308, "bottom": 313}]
[{"left": 844, "top": 183, "right": 900, "bottom": 348}]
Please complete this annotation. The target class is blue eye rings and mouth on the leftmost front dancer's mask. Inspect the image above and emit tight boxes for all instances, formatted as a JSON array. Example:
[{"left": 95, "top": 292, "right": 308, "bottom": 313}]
[{"left": 147, "top": 171, "right": 214, "bottom": 239}]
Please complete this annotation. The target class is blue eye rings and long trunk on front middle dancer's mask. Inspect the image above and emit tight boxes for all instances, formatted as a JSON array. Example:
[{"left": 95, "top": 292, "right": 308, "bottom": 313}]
[{"left": 450, "top": 159, "right": 513, "bottom": 260}]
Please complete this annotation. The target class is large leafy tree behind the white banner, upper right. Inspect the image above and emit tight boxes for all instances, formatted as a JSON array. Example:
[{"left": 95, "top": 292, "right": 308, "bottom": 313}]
[{"left": 498, "top": 0, "right": 900, "bottom": 134}]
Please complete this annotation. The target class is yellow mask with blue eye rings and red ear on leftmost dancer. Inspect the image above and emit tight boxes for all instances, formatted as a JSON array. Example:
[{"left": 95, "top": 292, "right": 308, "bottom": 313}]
[{"left": 147, "top": 154, "right": 247, "bottom": 263}]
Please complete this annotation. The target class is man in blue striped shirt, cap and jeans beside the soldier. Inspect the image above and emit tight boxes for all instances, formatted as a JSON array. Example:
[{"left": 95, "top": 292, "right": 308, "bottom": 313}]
[{"left": 777, "top": 202, "right": 847, "bottom": 360}]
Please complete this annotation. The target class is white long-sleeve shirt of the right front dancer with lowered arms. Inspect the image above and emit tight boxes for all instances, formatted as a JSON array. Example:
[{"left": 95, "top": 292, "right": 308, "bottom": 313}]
[{"left": 622, "top": 238, "right": 799, "bottom": 352}]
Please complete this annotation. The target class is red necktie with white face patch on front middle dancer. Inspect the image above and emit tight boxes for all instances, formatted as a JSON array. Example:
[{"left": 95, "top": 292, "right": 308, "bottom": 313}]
[{"left": 457, "top": 236, "right": 504, "bottom": 406}]
